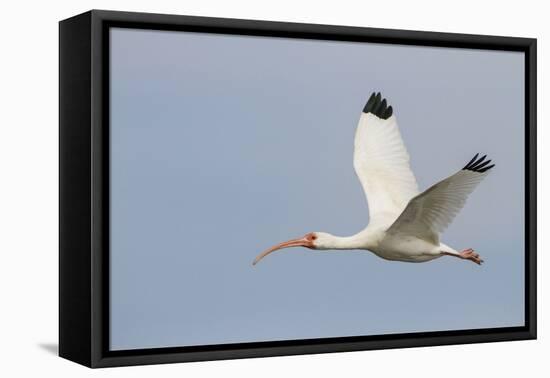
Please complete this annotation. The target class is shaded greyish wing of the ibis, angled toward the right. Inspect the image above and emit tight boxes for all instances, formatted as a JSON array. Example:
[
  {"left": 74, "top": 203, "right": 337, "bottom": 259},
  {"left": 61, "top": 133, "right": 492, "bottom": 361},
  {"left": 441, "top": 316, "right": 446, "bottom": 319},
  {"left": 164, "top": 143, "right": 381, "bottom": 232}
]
[{"left": 388, "top": 154, "right": 495, "bottom": 244}]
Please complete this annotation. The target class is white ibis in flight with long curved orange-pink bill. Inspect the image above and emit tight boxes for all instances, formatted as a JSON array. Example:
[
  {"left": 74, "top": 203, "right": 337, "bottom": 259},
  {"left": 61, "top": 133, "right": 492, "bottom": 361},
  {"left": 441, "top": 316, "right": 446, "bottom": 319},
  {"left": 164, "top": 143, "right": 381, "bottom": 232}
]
[{"left": 253, "top": 93, "right": 495, "bottom": 265}]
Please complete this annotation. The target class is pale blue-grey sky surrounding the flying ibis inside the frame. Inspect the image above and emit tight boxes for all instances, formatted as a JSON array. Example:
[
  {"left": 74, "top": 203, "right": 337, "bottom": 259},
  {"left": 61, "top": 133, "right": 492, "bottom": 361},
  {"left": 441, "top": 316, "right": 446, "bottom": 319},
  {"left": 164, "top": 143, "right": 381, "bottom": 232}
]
[{"left": 111, "top": 29, "right": 524, "bottom": 350}]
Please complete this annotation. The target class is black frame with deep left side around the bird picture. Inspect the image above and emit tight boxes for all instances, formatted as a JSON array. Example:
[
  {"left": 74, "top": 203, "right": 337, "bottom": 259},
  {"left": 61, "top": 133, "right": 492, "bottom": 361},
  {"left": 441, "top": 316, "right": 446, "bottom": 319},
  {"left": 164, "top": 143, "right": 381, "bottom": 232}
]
[{"left": 59, "top": 10, "right": 537, "bottom": 368}]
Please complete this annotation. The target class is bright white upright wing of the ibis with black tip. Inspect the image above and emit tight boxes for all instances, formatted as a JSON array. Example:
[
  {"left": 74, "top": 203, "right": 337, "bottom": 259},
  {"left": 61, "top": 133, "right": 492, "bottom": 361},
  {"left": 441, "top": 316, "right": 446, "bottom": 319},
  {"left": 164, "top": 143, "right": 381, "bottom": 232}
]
[{"left": 353, "top": 93, "right": 418, "bottom": 226}]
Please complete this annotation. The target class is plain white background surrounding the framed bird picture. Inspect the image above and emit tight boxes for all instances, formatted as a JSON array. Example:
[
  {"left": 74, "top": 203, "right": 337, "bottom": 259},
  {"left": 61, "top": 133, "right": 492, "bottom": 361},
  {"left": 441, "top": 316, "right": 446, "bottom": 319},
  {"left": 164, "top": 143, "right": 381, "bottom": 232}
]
[{"left": 0, "top": 0, "right": 550, "bottom": 378}]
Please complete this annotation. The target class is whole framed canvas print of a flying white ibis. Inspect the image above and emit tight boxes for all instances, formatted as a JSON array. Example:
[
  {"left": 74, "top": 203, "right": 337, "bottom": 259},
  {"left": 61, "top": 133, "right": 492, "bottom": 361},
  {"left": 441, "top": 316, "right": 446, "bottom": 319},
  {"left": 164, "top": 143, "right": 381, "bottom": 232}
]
[{"left": 59, "top": 10, "right": 536, "bottom": 367}]
